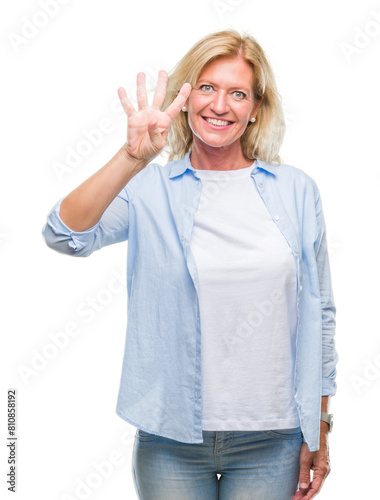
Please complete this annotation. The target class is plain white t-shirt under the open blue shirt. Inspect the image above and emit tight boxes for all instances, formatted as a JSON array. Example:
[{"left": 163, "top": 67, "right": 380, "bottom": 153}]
[{"left": 190, "top": 162, "right": 300, "bottom": 431}]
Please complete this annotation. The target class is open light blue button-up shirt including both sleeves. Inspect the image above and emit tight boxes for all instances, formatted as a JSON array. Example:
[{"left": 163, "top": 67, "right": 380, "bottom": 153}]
[{"left": 42, "top": 152, "right": 338, "bottom": 451}]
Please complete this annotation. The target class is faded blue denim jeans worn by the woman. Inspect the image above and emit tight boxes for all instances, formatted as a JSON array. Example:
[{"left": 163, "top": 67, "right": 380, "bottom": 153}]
[{"left": 132, "top": 427, "right": 302, "bottom": 500}]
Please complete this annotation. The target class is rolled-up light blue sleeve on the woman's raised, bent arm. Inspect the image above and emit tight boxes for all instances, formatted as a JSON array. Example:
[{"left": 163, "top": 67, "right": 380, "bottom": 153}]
[{"left": 42, "top": 187, "right": 129, "bottom": 257}]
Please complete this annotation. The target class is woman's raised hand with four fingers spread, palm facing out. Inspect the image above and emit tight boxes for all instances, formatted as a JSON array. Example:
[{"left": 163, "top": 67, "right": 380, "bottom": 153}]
[{"left": 118, "top": 71, "right": 191, "bottom": 161}]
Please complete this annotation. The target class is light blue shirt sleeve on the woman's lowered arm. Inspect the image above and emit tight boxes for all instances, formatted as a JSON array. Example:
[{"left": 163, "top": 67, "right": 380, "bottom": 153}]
[{"left": 314, "top": 186, "right": 338, "bottom": 396}]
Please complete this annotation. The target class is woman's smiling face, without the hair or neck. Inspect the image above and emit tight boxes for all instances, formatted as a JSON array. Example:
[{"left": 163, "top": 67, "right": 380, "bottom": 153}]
[{"left": 187, "top": 56, "right": 260, "bottom": 147}]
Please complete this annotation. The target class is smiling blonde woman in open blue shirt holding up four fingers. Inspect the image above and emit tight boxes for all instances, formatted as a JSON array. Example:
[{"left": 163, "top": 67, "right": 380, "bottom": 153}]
[{"left": 43, "top": 30, "right": 337, "bottom": 500}]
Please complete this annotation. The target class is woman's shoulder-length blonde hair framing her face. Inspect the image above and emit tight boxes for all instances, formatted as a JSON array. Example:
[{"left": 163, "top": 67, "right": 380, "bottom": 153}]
[{"left": 162, "top": 29, "right": 285, "bottom": 163}]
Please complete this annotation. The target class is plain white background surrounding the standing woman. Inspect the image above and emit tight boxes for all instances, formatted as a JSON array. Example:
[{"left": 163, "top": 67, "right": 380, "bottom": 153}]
[{"left": 0, "top": 0, "right": 380, "bottom": 500}]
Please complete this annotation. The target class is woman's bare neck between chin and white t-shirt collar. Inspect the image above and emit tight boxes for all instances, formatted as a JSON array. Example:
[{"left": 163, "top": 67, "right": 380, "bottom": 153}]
[{"left": 190, "top": 136, "right": 253, "bottom": 170}]
